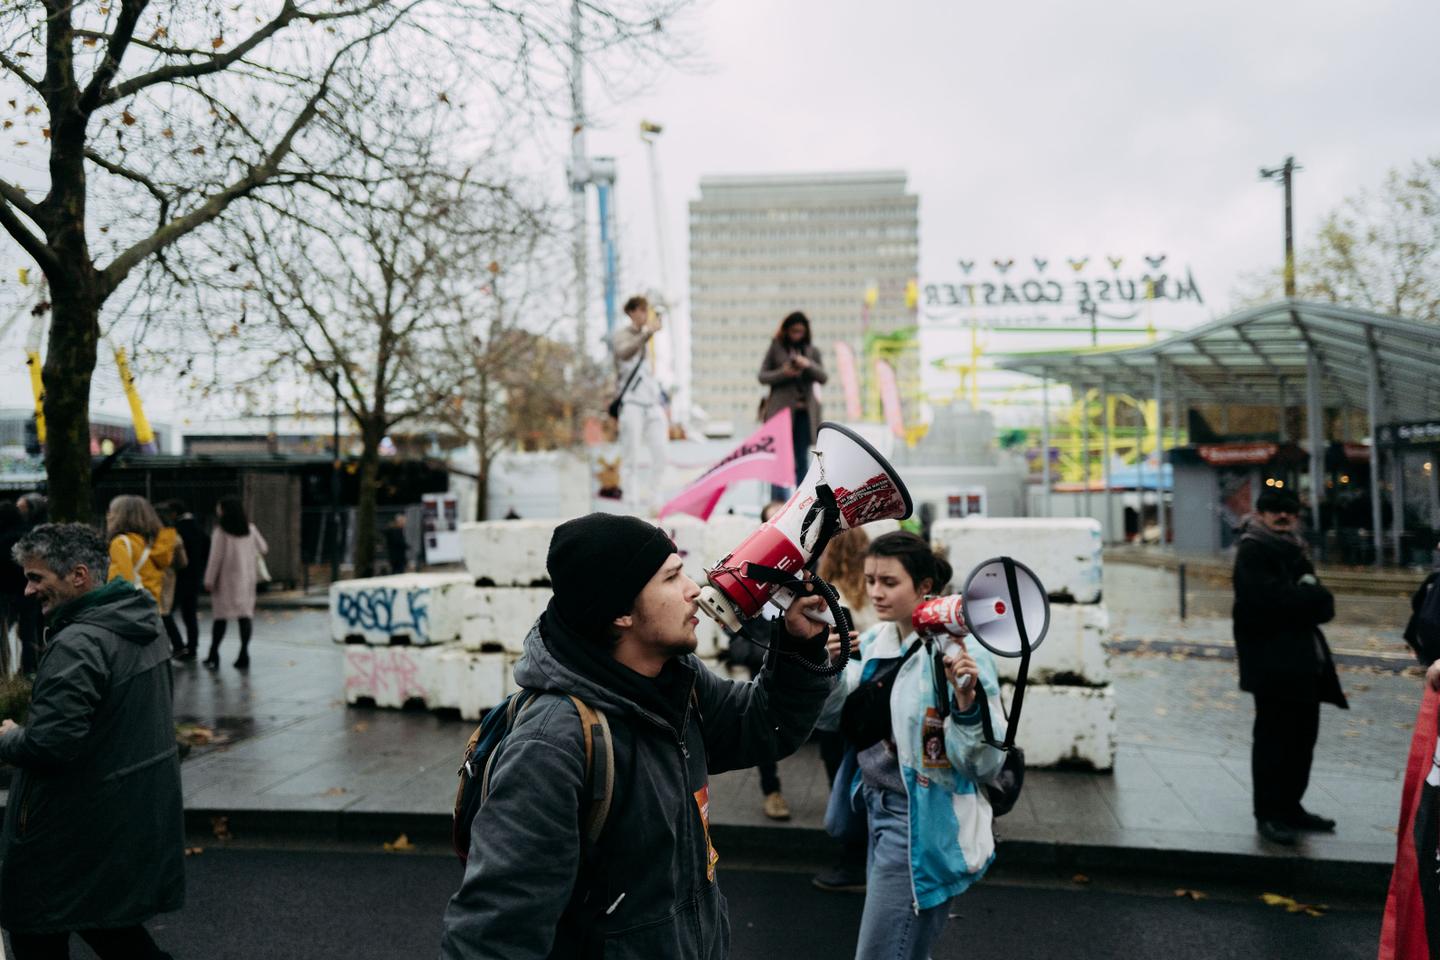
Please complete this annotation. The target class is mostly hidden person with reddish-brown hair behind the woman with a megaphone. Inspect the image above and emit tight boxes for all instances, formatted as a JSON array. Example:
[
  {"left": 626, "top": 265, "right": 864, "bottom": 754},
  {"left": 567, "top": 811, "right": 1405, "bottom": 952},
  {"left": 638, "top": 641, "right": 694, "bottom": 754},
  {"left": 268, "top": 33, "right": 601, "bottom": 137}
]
[{"left": 811, "top": 527, "right": 877, "bottom": 892}]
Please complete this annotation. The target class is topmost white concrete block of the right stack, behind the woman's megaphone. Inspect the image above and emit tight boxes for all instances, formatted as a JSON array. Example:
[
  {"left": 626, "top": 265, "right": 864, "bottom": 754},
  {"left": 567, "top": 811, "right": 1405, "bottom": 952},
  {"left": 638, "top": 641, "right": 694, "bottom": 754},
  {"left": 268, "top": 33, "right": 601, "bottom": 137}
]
[{"left": 930, "top": 517, "right": 1102, "bottom": 603}]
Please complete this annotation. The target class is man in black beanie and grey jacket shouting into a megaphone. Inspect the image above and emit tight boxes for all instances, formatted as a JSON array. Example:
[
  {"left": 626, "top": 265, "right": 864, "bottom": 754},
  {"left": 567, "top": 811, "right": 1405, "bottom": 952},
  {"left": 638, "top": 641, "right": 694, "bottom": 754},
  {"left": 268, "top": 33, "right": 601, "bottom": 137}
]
[{"left": 441, "top": 514, "right": 832, "bottom": 960}]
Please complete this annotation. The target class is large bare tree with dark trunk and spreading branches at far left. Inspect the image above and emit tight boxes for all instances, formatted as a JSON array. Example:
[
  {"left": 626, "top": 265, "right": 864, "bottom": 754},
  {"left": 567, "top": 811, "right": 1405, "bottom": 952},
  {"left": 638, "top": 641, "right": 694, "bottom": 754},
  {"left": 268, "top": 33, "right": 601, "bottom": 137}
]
[{"left": 0, "top": 0, "right": 685, "bottom": 520}]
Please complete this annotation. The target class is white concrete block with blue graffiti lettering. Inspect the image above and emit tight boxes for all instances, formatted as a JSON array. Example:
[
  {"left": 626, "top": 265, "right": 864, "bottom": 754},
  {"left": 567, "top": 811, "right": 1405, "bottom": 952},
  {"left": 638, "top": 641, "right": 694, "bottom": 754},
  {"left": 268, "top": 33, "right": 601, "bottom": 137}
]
[{"left": 330, "top": 573, "right": 469, "bottom": 646}]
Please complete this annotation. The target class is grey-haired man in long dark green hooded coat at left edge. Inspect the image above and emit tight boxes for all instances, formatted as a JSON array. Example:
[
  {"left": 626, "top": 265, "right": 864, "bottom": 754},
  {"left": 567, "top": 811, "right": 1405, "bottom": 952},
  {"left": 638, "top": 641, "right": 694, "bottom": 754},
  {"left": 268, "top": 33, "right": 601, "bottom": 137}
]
[{"left": 0, "top": 524, "right": 184, "bottom": 960}]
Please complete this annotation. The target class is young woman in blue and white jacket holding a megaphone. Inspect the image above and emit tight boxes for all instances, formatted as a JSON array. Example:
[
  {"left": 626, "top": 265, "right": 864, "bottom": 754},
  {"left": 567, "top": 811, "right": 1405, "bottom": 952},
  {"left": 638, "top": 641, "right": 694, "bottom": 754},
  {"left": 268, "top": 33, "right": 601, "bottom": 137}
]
[{"left": 829, "top": 533, "right": 1005, "bottom": 960}]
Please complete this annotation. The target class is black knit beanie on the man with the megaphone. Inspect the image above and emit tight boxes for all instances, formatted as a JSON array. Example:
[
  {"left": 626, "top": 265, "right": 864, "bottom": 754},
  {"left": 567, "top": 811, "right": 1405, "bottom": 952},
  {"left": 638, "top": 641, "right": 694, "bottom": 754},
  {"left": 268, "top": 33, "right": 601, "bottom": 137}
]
[{"left": 544, "top": 514, "right": 675, "bottom": 630}]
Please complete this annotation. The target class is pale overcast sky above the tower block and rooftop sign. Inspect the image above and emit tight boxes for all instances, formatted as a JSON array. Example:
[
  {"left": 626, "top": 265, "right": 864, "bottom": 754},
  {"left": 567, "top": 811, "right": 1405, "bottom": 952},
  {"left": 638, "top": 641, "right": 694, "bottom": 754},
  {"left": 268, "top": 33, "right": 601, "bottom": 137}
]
[{"left": 0, "top": 0, "right": 1440, "bottom": 428}]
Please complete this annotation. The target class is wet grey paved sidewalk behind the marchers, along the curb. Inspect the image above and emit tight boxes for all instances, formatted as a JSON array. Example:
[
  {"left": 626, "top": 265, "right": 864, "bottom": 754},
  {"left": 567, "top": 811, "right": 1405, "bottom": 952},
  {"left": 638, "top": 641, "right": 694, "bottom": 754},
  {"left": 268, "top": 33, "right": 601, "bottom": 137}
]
[{"left": 165, "top": 609, "right": 1420, "bottom": 882}]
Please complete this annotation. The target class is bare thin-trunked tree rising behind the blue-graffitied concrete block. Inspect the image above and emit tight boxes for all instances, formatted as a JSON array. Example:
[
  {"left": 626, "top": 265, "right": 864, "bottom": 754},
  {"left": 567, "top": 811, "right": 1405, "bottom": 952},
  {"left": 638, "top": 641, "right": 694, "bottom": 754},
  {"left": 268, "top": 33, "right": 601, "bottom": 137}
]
[{"left": 235, "top": 148, "right": 534, "bottom": 577}]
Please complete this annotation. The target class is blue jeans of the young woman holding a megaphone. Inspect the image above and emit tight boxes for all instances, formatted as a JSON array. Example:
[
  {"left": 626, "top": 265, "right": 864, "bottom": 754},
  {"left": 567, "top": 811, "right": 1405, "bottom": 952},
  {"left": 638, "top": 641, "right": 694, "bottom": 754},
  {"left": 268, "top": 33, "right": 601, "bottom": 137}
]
[{"left": 855, "top": 784, "right": 950, "bottom": 960}]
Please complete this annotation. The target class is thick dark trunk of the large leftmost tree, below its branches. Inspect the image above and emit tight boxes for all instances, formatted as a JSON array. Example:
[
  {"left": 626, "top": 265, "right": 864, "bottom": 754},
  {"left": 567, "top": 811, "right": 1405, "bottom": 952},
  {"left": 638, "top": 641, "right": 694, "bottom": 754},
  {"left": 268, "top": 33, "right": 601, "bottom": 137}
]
[{"left": 42, "top": 270, "right": 101, "bottom": 524}]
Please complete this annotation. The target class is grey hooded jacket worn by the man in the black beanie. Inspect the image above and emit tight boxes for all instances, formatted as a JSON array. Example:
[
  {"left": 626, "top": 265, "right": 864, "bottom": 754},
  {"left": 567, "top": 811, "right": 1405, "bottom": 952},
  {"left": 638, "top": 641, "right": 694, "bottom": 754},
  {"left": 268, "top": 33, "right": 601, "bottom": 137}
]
[{"left": 441, "top": 623, "right": 831, "bottom": 960}]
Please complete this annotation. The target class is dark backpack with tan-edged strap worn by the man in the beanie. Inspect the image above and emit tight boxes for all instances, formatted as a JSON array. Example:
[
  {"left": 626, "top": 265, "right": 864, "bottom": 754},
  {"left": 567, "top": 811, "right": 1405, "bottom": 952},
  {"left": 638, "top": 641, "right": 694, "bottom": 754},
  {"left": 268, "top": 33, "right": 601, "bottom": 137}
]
[{"left": 451, "top": 689, "right": 615, "bottom": 862}]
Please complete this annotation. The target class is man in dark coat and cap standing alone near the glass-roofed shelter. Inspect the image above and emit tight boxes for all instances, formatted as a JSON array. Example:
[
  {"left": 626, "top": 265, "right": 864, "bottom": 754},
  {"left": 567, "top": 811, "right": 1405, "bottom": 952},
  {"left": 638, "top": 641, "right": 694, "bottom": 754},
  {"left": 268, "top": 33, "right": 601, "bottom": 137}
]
[{"left": 1234, "top": 489, "right": 1348, "bottom": 846}]
